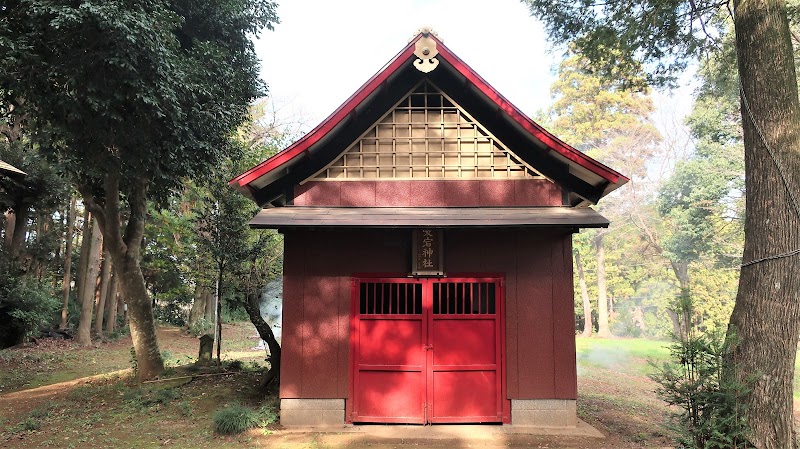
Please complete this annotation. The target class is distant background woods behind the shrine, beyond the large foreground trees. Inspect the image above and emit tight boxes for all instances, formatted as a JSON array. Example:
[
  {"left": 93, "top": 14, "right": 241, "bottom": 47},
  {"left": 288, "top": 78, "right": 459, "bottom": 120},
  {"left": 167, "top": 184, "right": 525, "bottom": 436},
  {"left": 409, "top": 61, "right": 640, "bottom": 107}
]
[{"left": 0, "top": 1, "right": 744, "bottom": 358}]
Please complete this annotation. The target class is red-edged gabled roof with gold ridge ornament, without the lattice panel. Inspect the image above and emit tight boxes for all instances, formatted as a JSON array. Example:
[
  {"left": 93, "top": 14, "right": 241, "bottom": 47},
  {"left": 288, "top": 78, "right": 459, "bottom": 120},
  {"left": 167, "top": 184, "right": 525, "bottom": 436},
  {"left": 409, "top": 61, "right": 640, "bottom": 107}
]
[{"left": 229, "top": 32, "right": 628, "bottom": 206}]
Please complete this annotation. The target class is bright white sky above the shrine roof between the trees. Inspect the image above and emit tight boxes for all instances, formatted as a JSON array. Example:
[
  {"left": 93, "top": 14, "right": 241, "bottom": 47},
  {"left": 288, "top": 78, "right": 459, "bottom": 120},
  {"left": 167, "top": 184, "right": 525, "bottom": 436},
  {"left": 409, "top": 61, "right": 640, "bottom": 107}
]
[{"left": 256, "top": 0, "right": 691, "bottom": 138}]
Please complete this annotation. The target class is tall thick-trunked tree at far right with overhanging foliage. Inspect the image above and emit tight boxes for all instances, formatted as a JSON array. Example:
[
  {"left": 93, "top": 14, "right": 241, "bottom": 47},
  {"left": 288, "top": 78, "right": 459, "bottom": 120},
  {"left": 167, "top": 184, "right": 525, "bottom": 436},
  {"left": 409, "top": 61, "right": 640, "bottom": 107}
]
[{"left": 524, "top": 0, "right": 800, "bottom": 448}]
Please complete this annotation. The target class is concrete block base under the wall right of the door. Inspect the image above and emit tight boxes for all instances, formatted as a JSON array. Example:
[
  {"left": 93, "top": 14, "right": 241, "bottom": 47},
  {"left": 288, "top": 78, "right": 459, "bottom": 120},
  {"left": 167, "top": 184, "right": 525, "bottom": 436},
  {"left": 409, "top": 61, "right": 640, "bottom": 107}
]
[{"left": 511, "top": 399, "right": 578, "bottom": 428}]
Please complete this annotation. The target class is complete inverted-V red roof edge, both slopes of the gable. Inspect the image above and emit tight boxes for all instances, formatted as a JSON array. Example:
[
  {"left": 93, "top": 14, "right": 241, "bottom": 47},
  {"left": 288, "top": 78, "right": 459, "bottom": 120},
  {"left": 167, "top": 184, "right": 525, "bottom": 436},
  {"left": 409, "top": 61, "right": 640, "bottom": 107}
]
[{"left": 228, "top": 33, "right": 629, "bottom": 191}]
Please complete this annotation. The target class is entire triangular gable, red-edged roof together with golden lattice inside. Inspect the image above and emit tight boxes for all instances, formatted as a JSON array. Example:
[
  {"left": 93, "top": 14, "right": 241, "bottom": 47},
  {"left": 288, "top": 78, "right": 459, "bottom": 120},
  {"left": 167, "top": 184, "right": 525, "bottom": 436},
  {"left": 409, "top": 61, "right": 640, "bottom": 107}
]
[{"left": 230, "top": 33, "right": 628, "bottom": 206}]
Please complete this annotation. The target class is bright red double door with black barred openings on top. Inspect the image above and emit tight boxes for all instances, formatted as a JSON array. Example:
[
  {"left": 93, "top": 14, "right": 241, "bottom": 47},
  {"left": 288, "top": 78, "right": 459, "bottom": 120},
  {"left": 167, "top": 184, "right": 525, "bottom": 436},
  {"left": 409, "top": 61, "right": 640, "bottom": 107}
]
[{"left": 351, "top": 278, "right": 503, "bottom": 424}]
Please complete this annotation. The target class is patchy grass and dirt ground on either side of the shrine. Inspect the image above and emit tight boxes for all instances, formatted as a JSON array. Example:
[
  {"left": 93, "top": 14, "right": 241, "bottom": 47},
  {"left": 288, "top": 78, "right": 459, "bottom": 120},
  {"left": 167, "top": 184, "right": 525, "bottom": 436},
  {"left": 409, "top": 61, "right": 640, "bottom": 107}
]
[{"left": 0, "top": 323, "right": 788, "bottom": 449}]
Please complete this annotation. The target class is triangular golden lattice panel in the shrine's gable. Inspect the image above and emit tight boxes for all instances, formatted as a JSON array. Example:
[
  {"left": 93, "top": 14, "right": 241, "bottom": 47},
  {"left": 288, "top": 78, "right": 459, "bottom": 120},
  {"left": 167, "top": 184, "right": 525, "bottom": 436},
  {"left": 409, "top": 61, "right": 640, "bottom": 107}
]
[{"left": 311, "top": 81, "right": 542, "bottom": 180}]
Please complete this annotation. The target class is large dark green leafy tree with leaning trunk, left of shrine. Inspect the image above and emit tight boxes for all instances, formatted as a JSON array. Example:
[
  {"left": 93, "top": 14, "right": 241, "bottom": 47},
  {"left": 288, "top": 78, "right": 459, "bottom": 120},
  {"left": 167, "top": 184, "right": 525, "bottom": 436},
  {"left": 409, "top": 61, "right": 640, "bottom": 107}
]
[{"left": 0, "top": 0, "right": 277, "bottom": 379}]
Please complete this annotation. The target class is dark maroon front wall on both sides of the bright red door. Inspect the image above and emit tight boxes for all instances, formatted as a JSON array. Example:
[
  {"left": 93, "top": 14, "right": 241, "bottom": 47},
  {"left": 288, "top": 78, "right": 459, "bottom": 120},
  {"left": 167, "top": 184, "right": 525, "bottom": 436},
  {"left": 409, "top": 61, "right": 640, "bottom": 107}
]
[{"left": 280, "top": 228, "right": 577, "bottom": 399}]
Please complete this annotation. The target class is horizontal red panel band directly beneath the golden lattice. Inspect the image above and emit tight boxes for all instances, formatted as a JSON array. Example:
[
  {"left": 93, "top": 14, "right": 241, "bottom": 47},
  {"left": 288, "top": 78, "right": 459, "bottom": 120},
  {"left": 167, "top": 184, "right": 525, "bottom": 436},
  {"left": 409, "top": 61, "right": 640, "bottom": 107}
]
[{"left": 294, "top": 179, "right": 561, "bottom": 207}]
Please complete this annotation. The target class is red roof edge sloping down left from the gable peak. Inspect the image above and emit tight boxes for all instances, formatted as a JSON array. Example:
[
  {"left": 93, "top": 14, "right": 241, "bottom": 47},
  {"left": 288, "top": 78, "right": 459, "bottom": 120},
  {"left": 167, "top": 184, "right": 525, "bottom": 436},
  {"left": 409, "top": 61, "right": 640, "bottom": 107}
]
[{"left": 228, "top": 34, "right": 424, "bottom": 189}]
